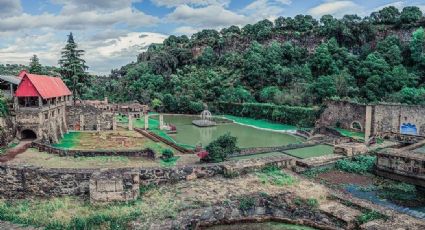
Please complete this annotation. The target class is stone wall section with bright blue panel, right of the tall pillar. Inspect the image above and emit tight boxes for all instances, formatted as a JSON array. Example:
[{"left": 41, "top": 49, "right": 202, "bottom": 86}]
[{"left": 372, "top": 105, "right": 425, "bottom": 136}]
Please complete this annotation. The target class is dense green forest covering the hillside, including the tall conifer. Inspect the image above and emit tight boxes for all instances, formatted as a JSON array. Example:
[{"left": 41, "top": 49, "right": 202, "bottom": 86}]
[{"left": 0, "top": 6, "right": 425, "bottom": 117}]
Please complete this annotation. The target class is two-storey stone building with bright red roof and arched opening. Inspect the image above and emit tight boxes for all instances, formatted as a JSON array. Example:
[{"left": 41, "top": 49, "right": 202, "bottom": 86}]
[{"left": 13, "top": 73, "right": 72, "bottom": 143}]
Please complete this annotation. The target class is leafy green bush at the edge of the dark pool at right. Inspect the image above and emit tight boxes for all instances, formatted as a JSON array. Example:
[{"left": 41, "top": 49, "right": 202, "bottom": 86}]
[{"left": 335, "top": 155, "right": 376, "bottom": 174}]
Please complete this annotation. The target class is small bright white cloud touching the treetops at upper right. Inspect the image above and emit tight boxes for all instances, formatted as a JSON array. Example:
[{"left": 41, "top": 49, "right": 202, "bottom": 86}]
[{"left": 308, "top": 1, "right": 366, "bottom": 17}]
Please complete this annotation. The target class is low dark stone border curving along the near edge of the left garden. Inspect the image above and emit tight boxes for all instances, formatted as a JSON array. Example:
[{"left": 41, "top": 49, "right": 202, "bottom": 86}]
[{"left": 31, "top": 142, "right": 155, "bottom": 159}]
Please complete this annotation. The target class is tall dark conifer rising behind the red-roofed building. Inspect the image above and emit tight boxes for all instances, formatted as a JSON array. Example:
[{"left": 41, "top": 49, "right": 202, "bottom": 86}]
[{"left": 59, "top": 33, "right": 89, "bottom": 103}]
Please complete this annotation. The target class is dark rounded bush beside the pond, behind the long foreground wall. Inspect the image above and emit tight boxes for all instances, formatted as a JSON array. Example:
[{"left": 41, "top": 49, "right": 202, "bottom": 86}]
[{"left": 202, "top": 133, "right": 239, "bottom": 162}]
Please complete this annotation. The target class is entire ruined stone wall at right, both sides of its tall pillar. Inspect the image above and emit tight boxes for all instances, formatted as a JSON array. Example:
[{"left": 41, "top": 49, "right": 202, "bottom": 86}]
[{"left": 316, "top": 101, "right": 425, "bottom": 140}]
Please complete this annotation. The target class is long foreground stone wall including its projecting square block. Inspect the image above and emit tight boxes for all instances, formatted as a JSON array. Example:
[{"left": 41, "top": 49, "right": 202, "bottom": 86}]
[{"left": 0, "top": 156, "right": 295, "bottom": 201}]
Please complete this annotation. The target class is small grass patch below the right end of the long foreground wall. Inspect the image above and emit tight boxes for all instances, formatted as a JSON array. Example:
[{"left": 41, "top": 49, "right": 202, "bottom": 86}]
[{"left": 257, "top": 166, "right": 296, "bottom": 186}]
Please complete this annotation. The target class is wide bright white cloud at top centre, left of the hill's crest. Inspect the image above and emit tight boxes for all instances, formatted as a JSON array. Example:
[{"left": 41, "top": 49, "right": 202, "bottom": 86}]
[{"left": 167, "top": 5, "right": 248, "bottom": 28}]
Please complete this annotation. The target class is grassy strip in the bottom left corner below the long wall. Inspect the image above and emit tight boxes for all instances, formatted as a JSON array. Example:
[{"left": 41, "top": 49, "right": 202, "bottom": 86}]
[{"left": 0, "top": 187, "right": 182, "bottom": 230}]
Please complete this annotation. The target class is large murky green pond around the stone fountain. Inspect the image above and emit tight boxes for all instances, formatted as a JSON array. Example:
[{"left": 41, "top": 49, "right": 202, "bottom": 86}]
[{"left": 164, "top": 115, "right": 303, "bottom": 148}]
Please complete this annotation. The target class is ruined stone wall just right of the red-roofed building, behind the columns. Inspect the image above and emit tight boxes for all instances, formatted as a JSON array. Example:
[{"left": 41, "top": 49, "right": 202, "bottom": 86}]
[{"left": 66, "top": 105, "right": 115, "bottom": 130}]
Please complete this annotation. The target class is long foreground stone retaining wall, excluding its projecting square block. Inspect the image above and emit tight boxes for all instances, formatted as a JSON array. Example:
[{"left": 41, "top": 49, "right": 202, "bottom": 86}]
[{"left": 0, "top": 157, "right": 295, "bottom": 198}]
